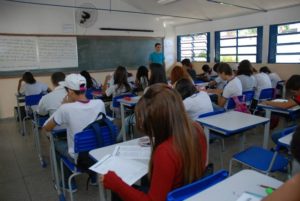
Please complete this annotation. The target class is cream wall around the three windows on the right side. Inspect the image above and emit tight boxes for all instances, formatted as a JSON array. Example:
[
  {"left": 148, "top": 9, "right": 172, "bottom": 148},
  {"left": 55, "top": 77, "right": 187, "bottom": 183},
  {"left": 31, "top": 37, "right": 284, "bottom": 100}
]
[{"left": 174, "top": 6, "right": 300, "bottom": 79}]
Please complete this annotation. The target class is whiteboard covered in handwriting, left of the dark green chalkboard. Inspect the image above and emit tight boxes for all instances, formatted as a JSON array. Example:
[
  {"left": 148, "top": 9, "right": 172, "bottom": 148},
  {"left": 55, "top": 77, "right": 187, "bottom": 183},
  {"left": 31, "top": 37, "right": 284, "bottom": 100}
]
[{"left": 0, "top": 35, "right": 78, "bottom": 71}]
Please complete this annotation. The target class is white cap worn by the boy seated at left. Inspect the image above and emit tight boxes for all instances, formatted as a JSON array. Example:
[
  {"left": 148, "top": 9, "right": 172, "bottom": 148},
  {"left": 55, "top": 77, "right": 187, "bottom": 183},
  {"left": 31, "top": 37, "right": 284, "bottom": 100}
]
[{"left": 59, "top": 74, "right": 86, "bottom": 91}]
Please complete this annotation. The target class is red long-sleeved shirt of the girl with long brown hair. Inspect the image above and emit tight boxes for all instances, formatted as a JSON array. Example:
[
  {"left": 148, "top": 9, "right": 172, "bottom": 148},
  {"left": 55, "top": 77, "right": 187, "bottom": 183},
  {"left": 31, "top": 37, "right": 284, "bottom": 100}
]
[{"left": 103, "top": 125, "right": 207, "bottom": 201}]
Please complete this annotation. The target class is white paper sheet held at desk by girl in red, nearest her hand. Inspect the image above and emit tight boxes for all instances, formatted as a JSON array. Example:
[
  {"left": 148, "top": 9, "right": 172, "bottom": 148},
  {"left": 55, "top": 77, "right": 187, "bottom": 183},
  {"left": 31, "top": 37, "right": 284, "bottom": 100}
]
[{"left": 89, "top": 155, "right": 148, "bottom": 185}]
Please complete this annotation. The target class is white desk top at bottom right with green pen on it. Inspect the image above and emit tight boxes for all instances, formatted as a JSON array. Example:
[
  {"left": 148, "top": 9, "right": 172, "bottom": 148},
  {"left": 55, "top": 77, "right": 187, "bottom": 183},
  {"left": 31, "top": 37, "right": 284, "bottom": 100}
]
[{"left": 186, "top": 170, "right": 282, "bottom": 201}]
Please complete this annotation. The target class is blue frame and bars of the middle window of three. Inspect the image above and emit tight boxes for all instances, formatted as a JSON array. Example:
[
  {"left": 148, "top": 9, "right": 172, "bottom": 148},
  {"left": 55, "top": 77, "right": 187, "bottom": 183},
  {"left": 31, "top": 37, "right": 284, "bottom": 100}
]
[{"left": 215, "top": 26, "right": 263, "bottom": 63}]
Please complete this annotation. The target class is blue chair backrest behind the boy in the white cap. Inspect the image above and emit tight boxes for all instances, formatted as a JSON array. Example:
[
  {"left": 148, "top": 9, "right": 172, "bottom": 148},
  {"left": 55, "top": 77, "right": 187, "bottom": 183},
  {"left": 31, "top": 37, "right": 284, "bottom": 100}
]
[{"left": 74, "top": 126, "right": 117, "bottom": 153}]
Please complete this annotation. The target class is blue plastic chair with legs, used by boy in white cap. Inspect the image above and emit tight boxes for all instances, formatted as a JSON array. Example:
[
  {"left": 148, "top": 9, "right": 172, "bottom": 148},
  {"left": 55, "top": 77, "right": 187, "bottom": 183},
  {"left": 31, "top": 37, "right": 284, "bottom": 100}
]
[{"left": 60, "top": 126, "right": 118, "bottom": 201}]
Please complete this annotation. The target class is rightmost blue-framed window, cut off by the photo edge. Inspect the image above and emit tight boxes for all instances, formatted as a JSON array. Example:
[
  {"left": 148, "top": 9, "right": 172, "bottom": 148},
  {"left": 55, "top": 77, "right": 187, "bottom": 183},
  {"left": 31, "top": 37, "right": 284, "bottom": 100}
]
[{"left": 269, "top": 22, "right": 300, "bottom": 63}]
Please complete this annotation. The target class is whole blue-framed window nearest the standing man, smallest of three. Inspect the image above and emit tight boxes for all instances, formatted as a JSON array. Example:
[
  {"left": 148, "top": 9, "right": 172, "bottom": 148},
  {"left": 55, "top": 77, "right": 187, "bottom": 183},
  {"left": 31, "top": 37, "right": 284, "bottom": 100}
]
[{"left": 177, "top": 33, "right": 210, "bottom": 62}]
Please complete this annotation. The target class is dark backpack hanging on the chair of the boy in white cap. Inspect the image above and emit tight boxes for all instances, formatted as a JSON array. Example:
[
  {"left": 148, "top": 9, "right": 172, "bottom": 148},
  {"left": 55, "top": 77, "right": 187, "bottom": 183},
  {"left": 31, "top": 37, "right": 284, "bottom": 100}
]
[{"left": 76, "top": 112, "right": 119, "bottom": 188}]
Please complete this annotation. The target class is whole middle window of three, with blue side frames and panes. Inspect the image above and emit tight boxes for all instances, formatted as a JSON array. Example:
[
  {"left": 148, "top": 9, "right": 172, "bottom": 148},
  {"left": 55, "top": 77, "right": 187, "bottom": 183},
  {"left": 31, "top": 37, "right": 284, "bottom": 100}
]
[{"left": 215, "top": 27, "right": 262, "bottom": 63}]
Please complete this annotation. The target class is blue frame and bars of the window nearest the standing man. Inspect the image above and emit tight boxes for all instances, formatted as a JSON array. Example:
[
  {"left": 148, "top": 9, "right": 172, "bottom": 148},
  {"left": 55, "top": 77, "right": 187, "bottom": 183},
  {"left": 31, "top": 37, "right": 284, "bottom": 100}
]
[{"left": 177, "top": 32, "right": 210, "bottom": 63}]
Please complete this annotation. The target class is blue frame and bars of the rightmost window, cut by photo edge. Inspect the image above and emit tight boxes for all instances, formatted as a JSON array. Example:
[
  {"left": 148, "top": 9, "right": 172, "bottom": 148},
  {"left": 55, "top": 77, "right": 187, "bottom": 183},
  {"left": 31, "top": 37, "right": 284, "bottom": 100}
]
[{"left": 268, "top": 21, "right": 300, "bottom": 64}]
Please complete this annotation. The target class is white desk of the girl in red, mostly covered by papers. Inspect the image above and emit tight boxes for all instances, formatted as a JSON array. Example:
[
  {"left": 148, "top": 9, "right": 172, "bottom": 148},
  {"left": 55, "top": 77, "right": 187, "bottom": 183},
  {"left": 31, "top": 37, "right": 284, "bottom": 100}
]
[{"left": 89, "top": 138, "right": 149, "bottom": 201}]
